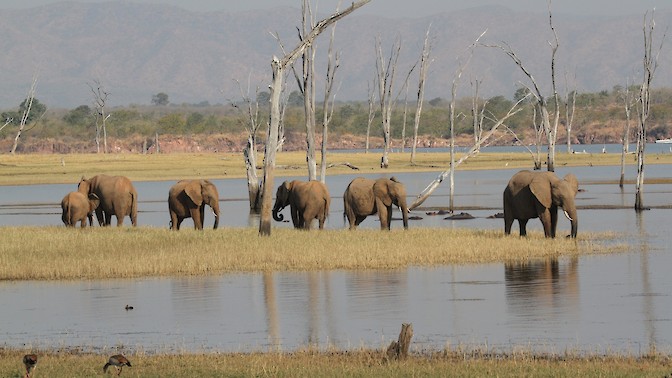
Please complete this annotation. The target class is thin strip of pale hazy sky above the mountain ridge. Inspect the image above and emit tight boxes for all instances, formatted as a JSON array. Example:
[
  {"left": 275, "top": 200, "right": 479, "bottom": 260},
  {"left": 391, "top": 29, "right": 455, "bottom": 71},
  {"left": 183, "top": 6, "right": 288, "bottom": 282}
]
[{"left": 0, "top": 0, "right": 660, "bottom": 17}]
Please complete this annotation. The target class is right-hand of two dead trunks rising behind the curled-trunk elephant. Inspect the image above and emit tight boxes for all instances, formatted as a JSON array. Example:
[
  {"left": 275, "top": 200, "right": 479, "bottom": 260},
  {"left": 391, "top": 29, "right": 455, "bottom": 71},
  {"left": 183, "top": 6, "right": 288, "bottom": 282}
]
[{"left": 320, "top": 1, "right": 341, "bottom": 183}]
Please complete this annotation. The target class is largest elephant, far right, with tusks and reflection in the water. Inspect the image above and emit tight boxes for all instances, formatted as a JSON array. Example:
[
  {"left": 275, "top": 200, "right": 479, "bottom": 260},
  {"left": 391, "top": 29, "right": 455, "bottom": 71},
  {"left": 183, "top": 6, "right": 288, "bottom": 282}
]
[{"left": 504, "top": 171, "right": 579, "bottom": 238}]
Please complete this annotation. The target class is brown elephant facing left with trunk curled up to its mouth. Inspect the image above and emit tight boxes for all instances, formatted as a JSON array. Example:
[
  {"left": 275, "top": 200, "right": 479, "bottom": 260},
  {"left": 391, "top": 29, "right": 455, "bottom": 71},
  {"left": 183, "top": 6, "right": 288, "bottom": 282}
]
[{"left": 273, "top": 180, "right": 331, "bottom": 230}]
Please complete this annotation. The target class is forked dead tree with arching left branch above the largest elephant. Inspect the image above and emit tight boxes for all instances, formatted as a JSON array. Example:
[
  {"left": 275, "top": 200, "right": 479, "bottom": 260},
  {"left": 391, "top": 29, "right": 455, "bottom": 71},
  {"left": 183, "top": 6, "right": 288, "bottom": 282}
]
[{"left": 486, "top": 0, "right": 560, "bottom": 172}]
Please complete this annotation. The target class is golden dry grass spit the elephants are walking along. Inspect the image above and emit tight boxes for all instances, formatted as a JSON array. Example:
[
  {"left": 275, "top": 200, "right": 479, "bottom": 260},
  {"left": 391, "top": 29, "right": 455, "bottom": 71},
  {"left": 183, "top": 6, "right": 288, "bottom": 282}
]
[{"left": 0, "top": 227, "right": 626, "bottom": 280}]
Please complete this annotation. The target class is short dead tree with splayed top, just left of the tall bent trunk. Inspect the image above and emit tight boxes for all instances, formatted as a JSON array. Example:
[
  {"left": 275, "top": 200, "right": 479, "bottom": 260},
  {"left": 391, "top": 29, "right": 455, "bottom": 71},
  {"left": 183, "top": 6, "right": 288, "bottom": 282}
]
[{"left": 230, "top": 76, "right": 262, "bottom": 214}]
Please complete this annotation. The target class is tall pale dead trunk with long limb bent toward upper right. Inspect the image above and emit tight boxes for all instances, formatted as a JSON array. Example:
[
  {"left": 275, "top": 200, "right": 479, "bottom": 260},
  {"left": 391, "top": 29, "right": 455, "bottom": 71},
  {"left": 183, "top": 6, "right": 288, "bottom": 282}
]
[{"left": 259, "top": 0, "right": 371, "bottom": 236}]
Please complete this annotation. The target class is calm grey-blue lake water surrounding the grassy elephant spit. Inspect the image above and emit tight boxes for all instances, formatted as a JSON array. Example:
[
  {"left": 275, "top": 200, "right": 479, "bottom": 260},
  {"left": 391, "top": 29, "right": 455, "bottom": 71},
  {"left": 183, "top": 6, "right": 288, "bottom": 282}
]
[{"left": 0, "top": 151, "right": 672, "bottom": 353}]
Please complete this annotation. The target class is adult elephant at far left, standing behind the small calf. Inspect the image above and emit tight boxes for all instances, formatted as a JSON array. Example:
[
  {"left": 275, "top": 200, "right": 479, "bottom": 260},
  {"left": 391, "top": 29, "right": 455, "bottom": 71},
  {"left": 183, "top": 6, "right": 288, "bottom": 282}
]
[{"left": 78, "top": 175, "right": 138, "bottom": 227}]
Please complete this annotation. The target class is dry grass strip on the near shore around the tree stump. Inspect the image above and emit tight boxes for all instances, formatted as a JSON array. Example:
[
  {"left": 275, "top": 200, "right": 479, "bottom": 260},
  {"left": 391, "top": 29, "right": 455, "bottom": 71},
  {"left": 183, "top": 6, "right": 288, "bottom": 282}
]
[{"left": 0, "top": 349, "right": 672, "bottom": 378}]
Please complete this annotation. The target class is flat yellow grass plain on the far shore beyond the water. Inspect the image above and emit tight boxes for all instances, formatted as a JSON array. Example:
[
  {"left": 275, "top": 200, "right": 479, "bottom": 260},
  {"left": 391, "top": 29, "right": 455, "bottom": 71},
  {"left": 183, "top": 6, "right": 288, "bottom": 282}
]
[{"left": 0, "top": 152, "right": 672, "bottom": 185}]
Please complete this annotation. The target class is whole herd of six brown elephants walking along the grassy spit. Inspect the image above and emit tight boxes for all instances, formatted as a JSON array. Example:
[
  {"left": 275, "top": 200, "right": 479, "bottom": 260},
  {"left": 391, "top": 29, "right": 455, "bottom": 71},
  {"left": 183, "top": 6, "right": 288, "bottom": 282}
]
[{"left": 61, "top": 171, "right": 579, "bottom": 237}]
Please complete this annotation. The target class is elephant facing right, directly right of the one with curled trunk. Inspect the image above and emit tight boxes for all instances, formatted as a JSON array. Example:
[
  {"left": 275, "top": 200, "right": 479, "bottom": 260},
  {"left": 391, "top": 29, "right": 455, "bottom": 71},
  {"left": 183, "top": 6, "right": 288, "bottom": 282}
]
[{"left": 343, "top": 177, "right": 408, "bottom": 230}]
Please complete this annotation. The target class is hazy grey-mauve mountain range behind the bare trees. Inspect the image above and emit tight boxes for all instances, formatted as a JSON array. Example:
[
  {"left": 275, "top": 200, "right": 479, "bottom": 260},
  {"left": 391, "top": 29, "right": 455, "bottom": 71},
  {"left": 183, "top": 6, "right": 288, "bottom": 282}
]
[{"left": 0, "top": 1, "right": 672, "bottom": 109}]
